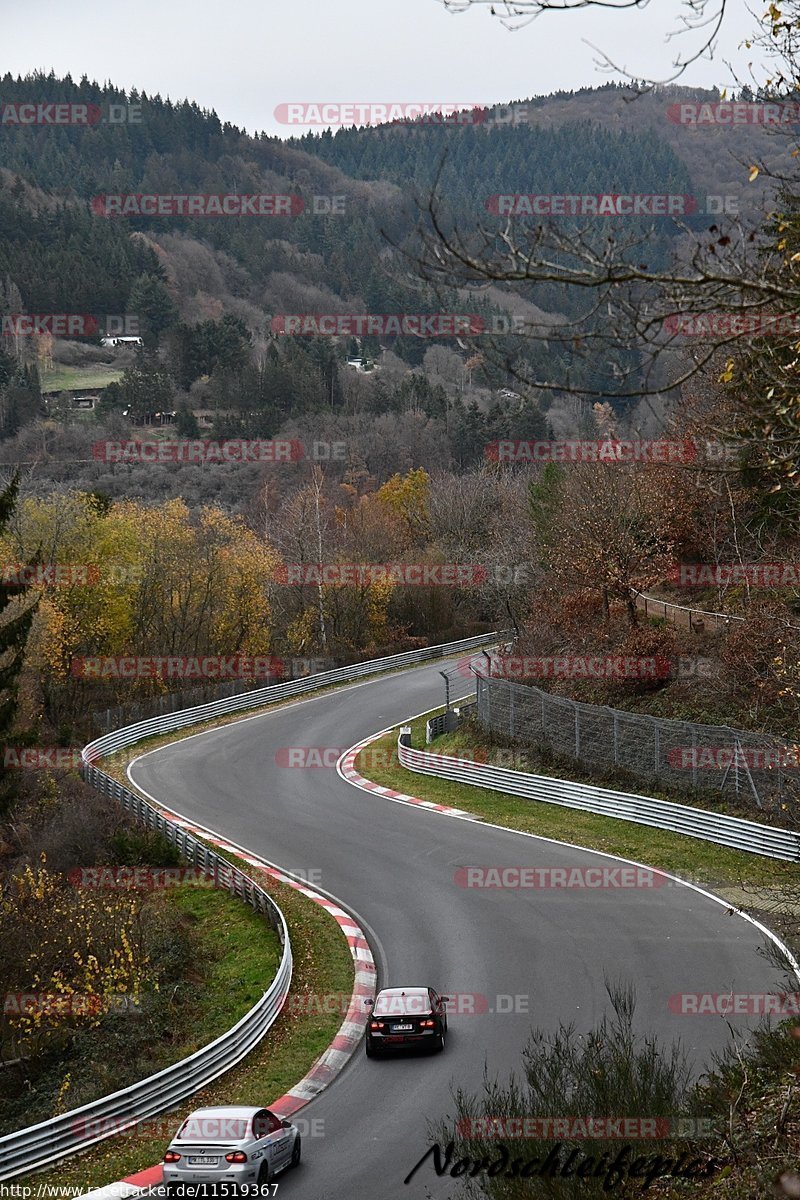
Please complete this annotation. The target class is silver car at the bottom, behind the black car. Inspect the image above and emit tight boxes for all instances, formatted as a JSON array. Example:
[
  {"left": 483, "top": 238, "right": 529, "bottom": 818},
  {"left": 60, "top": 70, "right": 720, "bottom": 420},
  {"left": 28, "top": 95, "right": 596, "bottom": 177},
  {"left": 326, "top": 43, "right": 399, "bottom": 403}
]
[{"left": 163, "top": 1106, "right": 300, "bottom": 1200}]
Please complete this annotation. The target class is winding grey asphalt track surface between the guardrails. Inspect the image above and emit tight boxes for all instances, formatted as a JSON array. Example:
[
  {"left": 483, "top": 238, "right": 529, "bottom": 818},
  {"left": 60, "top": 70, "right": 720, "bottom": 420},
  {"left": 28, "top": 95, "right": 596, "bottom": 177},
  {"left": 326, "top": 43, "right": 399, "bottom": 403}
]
[{"left": 132, "top": 664, "right": 780, "bottom": 1200}]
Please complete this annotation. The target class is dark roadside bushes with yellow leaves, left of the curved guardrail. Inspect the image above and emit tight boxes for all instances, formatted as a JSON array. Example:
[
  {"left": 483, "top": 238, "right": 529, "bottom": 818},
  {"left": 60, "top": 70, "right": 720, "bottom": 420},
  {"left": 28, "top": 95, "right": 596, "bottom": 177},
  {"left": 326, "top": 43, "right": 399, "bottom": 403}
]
[{"left": 0, "top": 772, "right": 201, "bottom": 1132}]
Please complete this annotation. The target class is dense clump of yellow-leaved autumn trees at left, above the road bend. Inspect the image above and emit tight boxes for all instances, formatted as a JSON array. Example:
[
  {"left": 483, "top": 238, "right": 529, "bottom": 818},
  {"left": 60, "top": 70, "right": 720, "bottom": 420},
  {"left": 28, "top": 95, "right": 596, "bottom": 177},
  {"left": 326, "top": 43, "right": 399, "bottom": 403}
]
[{"left": 0, "top": 493, "right": 277, "bottom": 710}]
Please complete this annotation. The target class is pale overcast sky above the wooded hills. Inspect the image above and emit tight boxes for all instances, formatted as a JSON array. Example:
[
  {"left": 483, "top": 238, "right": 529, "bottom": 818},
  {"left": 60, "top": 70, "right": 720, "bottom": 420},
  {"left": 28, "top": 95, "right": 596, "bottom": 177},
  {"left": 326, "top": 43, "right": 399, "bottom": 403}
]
[{"left": 0, "top": 0, "right": 760, "bottom": 136}]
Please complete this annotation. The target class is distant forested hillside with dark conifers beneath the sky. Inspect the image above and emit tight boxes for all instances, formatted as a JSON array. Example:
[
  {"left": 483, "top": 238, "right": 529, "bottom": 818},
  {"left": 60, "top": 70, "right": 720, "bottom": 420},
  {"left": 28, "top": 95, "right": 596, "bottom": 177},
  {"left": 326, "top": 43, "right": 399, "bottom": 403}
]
[{"left": 0, "top": 76, "right": 784, "bottom": 456}]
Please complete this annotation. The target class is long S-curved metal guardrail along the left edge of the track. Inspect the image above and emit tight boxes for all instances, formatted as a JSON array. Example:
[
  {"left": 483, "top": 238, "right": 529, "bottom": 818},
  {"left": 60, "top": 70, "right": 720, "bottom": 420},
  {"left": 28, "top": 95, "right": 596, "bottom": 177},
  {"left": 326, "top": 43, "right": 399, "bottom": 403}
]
[{"left": 0, "top": 634, "right": 498, "bottom": 1181}]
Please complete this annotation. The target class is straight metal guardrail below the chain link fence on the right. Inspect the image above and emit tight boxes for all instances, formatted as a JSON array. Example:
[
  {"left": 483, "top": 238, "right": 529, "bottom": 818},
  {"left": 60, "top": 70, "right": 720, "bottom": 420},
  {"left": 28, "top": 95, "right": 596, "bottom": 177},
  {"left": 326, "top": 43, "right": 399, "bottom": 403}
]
[{"left": 397, "top": 733, "right": 800, "bottom": 863}]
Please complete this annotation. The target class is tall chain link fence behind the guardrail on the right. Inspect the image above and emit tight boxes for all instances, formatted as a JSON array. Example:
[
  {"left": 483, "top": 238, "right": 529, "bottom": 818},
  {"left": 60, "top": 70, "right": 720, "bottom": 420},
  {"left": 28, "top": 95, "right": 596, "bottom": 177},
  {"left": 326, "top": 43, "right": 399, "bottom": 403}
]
[{"left": 476, "top": 673, "right": 800, "bottom": 812}]
